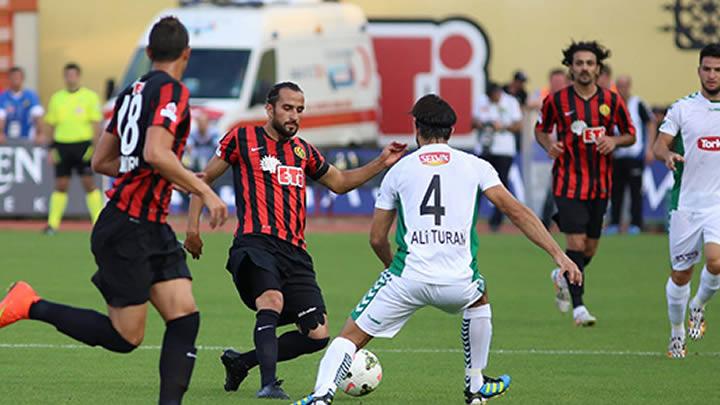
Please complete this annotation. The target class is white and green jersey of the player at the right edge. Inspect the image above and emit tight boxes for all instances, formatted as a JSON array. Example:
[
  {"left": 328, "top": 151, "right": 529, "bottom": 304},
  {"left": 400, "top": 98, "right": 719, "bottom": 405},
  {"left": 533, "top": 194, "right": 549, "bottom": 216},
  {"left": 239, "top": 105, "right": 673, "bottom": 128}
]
[{"left": 660, "top": 92, "right": 720, "bottom": 211}]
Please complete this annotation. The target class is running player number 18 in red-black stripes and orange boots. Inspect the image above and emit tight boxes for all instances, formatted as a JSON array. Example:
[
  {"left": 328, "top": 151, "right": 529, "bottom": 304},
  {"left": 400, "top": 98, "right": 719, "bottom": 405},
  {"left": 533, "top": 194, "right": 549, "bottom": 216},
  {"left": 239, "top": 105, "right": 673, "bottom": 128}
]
[{"left": 0, "top": 17, "right": 227, "bottom": 405}]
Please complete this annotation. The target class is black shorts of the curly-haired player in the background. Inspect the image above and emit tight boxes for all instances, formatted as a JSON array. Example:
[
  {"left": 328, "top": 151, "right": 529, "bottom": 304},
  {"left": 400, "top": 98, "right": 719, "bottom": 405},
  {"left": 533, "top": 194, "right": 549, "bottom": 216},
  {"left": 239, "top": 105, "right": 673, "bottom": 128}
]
[{"left": 553, "top": 196, "right": 608, "bottom": 239}]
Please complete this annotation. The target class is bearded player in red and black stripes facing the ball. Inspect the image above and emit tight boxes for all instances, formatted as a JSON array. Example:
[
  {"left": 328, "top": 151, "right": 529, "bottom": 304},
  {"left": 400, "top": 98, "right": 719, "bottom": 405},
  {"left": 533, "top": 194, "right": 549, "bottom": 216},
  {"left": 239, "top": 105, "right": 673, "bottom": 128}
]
[{"left": 185, "top": 82, "right": 406, "bottom": 399}]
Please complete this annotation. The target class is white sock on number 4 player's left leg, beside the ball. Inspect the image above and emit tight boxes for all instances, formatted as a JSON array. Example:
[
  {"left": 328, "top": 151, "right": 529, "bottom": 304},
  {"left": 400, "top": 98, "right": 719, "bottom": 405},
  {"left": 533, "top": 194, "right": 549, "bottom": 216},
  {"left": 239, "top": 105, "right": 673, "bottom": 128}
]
[{"left": 314, "top": 337, "right": 357, "bottom": 397}]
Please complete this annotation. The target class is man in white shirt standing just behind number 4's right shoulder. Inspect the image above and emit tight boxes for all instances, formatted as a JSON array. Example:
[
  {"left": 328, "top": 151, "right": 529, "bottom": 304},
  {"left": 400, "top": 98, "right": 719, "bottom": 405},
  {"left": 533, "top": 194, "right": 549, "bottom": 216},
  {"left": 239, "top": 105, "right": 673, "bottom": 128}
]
[{"left": 473, "top": 82, "right": 522, "bottom": 232}]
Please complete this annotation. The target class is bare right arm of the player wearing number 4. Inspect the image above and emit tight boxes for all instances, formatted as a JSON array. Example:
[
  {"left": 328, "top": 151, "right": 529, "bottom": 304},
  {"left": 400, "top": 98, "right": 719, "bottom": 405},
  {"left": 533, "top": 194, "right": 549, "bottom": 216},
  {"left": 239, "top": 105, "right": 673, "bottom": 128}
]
[{"left": 485, "top": 185, "right": 582, "bottom": 284}]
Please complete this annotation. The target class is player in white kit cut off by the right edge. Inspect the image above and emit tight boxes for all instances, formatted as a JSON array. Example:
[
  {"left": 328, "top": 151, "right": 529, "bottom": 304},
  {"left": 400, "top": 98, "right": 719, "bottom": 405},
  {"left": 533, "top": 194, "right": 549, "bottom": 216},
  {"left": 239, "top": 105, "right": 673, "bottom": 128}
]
[{"left": 654, "top": 44, "right": 720, "bottom": 358}]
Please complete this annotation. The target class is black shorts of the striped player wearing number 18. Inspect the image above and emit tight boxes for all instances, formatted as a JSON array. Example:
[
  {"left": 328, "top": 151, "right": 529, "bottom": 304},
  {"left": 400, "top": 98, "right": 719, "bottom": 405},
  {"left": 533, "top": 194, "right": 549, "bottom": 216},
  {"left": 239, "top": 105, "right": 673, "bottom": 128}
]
[{"left": 90, "top": 204, "right": 192, "bottom": 307}]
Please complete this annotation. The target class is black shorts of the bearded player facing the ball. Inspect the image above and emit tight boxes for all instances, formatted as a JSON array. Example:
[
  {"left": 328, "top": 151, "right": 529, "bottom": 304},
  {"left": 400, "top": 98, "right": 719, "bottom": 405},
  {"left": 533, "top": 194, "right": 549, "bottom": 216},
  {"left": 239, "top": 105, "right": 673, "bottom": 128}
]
[{"left": 227, "top": 234, "right": 325, "bottom": 325}]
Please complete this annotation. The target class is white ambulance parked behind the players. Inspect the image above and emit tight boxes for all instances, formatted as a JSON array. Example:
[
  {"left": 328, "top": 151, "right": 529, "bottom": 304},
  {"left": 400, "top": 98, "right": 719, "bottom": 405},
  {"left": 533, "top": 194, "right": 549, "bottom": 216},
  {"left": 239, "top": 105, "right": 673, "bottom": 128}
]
[{"left": 113, "top": 0, "right": 379, "bottom": 147}]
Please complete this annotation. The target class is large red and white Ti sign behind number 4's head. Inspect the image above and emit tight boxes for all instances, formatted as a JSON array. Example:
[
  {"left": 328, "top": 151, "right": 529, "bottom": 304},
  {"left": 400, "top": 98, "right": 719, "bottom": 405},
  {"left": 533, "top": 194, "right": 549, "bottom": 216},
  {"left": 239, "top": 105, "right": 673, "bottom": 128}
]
[{"left": 368, "top": 19, "right": 489, "bottom": 147}]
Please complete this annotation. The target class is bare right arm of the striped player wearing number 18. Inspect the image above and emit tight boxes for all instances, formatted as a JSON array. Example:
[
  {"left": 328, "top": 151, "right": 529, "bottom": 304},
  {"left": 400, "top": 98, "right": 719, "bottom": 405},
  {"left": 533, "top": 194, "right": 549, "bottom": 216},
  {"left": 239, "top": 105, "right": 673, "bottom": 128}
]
[{"left": 143, "top": 126, "right": 228, "bottom": 228}]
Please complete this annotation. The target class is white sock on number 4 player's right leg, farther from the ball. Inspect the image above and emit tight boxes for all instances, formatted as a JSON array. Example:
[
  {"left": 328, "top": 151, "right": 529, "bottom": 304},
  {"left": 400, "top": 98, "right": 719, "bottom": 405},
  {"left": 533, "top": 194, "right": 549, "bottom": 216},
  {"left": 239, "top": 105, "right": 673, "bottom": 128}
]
[{"left": 462, "top": 304, "right": 492, "bottom": 392}]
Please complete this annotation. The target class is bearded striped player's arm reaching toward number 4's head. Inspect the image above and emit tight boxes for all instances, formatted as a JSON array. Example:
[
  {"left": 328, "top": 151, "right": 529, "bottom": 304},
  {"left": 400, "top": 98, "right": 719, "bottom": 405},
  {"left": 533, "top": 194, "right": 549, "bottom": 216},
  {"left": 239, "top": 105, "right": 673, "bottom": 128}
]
[{"left": 320, "top": 142, "right": 407, "bottom": 194}]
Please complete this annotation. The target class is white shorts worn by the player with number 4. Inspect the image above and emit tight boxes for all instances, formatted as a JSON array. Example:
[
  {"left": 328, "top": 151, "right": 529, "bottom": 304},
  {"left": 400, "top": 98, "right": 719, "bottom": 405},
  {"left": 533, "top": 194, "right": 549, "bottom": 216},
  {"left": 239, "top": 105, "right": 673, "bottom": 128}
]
[{"left": 350, "top": 270, "right": 485, "bottom": 338}]
